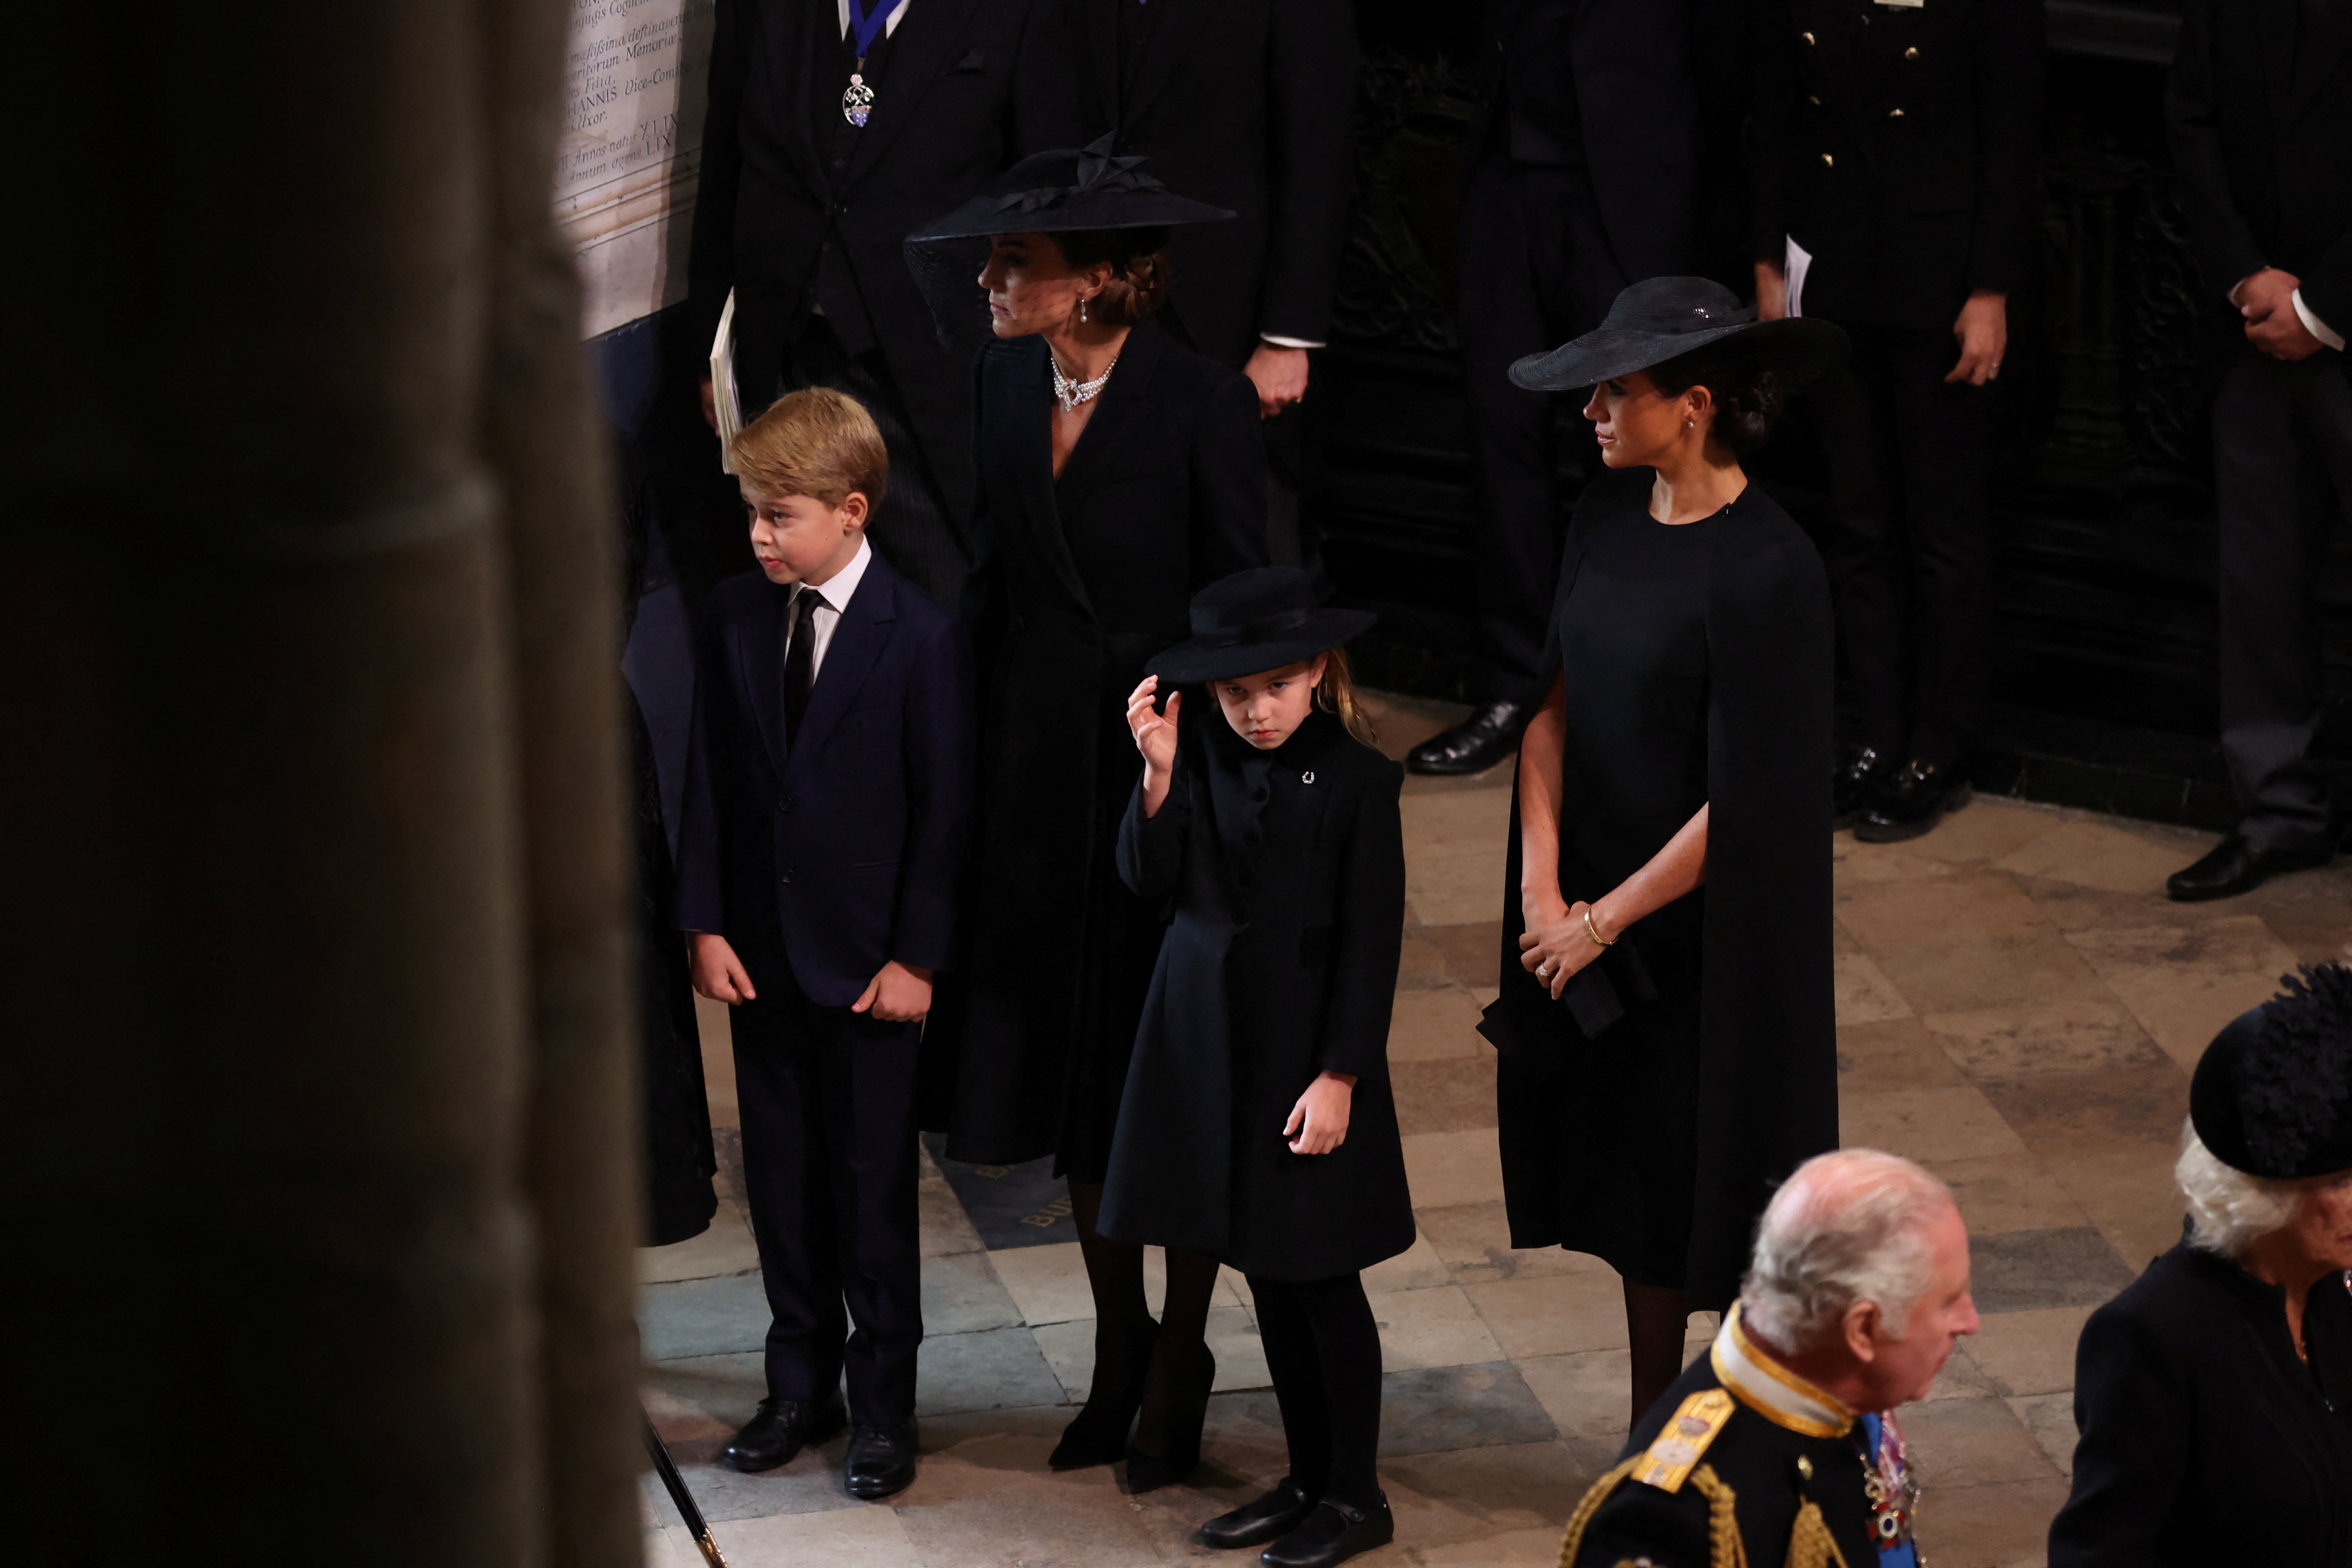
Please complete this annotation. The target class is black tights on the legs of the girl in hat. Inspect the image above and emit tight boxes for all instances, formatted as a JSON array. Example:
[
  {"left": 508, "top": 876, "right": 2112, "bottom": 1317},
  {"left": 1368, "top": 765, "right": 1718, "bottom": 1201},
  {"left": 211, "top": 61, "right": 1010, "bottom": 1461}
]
[{"left": 1249, "top": 1274, "right": 1381, "bottom": 1509}]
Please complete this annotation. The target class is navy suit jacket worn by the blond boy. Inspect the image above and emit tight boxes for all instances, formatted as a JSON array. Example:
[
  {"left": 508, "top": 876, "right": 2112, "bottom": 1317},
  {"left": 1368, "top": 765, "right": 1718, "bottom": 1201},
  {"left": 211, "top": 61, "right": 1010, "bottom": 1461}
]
[{"left": 677, "top": 552, "right": 974, "bottom": 1006}]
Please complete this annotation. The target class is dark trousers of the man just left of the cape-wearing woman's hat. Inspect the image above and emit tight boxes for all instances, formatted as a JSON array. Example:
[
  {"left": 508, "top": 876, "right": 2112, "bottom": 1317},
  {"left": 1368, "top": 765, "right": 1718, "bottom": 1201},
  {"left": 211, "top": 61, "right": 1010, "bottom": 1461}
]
[{"left": 1458, "top": 151, "right": 1632, "bottom": 703}]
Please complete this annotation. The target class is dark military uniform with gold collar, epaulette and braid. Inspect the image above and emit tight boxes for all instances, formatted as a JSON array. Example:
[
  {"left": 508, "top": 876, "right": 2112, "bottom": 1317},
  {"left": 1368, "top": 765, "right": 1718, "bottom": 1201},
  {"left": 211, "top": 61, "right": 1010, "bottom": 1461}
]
[{"left": 1559, "top": 1307, "right": 1917, "bottom": 1568}]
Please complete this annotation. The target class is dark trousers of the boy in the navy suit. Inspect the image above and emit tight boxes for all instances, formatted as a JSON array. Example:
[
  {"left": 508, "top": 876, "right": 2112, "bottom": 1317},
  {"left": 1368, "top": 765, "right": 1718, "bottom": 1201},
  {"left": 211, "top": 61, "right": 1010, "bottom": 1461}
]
[{"left": 729, "top": 964, "right": 922, "bottom": 1425}]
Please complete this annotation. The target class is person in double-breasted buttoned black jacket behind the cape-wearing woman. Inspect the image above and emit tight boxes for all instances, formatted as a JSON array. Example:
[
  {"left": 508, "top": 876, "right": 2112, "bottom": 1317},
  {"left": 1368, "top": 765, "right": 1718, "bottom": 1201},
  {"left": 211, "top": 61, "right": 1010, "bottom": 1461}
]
[{"left": 1750, "top": 0, "right": 2044, "bottom": 842}]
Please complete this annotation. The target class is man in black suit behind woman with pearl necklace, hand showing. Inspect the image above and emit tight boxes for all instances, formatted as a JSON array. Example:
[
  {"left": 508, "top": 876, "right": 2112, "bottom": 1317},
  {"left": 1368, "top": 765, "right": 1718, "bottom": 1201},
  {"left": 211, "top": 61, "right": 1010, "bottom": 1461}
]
[{"left": 1073, "top": 0, "right": 1357, "bottom": 571}]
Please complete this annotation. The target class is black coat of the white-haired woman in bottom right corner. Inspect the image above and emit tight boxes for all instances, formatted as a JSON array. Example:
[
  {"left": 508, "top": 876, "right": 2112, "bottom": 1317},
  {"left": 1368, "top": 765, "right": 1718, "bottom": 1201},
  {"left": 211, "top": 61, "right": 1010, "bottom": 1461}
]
[{"left": 2049, "top": 1241, "right": 2352, "bottom": 1568}]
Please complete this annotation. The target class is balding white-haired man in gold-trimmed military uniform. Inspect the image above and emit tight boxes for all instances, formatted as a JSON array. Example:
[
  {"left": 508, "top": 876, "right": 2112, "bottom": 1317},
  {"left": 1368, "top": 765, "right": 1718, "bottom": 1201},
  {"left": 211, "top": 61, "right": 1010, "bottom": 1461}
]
[{"left": 1559, "top": 1150, "right": 1976, "bottom": 1568}]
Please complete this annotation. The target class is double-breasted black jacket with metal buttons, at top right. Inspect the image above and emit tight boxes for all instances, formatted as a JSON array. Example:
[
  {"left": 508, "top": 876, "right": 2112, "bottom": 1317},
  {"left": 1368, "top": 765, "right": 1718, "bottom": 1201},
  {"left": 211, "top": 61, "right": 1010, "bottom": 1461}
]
[{"left": 1750, "top": 0, "right": 2044, "bottom": 329}]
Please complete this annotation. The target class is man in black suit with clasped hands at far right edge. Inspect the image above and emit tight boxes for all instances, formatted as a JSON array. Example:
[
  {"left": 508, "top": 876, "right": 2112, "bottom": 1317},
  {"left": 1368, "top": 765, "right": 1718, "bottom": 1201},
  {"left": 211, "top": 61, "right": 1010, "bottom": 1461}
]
[{"left": 2164, "top": 0, "right": 2352, "bottom": 900}]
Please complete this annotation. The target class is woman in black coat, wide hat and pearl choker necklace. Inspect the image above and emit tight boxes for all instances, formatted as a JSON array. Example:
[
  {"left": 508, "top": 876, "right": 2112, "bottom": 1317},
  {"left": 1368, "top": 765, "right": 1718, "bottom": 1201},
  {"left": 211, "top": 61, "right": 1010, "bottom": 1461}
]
[{"left": 922, "top": 151, "right": 1265, "bottom": 1483}]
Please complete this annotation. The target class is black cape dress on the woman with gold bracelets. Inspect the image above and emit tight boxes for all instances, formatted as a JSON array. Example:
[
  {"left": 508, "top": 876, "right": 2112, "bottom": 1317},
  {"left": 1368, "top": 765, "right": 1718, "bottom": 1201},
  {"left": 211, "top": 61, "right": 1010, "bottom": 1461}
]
[{"left": 1482, "top": 468, "right": 1837, "bottom": 1312}]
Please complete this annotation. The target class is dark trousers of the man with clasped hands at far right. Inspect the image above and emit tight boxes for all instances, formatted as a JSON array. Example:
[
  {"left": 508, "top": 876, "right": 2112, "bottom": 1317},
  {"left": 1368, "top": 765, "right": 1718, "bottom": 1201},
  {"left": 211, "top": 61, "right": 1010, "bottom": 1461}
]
[{"left": 2213, "top": 348, "right": 2352, "bottom": 853}]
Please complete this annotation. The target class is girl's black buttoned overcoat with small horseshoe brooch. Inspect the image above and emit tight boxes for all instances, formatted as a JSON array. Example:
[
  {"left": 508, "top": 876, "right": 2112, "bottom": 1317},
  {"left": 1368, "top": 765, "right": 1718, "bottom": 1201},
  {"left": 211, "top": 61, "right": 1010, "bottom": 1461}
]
[{"left": 1101, "top": 719, "right": 1414, "bottom": 1279}]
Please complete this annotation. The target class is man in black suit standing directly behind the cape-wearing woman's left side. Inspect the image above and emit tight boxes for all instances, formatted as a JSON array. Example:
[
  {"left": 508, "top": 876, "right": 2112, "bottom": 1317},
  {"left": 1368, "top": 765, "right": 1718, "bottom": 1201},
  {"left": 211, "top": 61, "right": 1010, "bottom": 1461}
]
[{"left": 1406, "top": 0, "right": 1698, "bottom": 773}]
